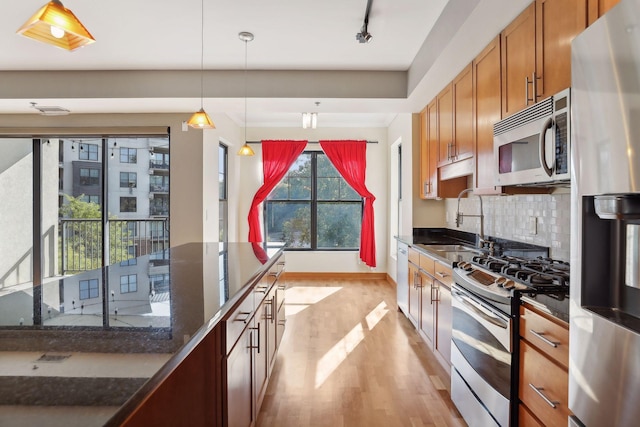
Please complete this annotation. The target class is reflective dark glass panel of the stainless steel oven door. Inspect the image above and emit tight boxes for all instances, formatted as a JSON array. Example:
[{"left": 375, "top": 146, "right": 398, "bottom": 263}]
[{"left": 452, "top": 301, "right": 511, "bottom": 399}]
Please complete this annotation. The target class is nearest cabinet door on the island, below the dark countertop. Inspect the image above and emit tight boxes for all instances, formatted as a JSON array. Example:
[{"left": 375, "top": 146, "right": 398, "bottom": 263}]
[{"left": 226, "top": 328, "right": 253, "bottom": 427}]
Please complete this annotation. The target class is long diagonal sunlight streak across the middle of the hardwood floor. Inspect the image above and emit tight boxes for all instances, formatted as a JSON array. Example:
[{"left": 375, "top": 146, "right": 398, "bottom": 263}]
[{"left": 316, "top": 301, "right": 389, "bottom": 389}]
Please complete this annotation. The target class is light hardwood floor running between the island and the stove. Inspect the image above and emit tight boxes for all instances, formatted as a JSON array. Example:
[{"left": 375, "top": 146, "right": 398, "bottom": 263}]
[{"left": 257, "top": 279, "right": 466, "bottom": 427}]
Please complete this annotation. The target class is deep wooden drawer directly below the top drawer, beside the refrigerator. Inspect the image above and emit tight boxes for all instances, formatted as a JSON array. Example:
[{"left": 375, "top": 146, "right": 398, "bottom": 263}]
[{"left": 518, "top": 341, "right": 570, "bottom": 426}]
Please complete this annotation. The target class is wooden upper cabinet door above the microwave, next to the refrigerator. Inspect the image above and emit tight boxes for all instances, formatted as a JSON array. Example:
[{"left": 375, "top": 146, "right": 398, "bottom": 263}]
[{"left": 536, "top": 0, "right": 587, "bottom": 99}]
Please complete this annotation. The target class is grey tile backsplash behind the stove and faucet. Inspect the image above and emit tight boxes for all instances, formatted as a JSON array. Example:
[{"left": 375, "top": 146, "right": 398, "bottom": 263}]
[{"left": 445, "top": 193, "right": 571, "bottom": 261}]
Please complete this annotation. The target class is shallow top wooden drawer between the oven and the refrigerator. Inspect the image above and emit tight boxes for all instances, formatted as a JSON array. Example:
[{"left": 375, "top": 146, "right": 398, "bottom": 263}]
[{"left": 520, "top": 306, "right": 569, "bottom": 369}]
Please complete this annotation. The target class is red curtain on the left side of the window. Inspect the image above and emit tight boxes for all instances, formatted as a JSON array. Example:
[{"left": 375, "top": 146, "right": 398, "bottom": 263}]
[{"left": 248, "top": 141, "right": 307, "bottom": 242}]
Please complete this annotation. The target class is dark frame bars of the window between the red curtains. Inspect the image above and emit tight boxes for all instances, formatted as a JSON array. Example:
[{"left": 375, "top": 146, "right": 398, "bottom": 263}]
[{"left": 262, "top": 150, "right": 364, "bottom": 252}]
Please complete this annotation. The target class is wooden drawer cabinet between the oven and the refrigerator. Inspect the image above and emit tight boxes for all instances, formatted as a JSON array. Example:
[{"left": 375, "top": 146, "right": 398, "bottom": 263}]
[{"left": 518, "top": 305, "right": 571, "bottom": 426}]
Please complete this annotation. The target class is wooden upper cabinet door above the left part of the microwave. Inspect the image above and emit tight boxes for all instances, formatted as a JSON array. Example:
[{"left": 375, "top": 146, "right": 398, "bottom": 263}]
[{"left": 500, "top": 3, "right": 536, "bottom": 118}]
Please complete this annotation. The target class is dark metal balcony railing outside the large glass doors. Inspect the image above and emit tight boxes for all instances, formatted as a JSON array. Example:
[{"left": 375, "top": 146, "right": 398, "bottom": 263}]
[{"left": 59, "top": 218, "right": 169, "bottom": 275}]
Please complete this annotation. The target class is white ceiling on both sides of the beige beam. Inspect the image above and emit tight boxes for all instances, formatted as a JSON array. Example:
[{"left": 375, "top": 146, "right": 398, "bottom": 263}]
[{"left": 0, "top": 0, "right": 469, "bottom": 126}]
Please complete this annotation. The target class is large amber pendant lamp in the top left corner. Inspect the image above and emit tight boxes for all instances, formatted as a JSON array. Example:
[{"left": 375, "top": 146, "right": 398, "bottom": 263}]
[{"left": 16, "top": 0, "right": 96, "bottom": 50}]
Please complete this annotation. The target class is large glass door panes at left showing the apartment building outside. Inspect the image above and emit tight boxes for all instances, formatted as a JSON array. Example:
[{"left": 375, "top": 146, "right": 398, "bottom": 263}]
[{"left": 0, "top": 136, "right": 170, "bottom": 327}]
